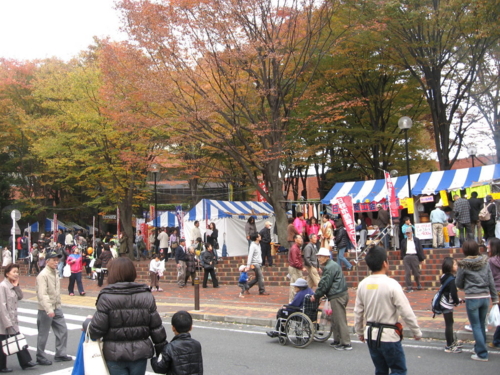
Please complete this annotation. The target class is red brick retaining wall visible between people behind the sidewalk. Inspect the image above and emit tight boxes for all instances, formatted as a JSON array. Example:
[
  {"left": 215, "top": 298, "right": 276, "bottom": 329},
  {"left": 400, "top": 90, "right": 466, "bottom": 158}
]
[{"left": 11, "top": 248, "right": 474, "bottom": 289}]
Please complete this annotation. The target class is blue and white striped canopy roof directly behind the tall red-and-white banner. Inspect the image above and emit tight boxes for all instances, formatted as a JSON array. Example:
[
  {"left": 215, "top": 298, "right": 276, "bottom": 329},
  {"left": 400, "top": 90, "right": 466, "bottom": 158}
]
[{"left": 321, "top": 173, "right": 420, "bottom": 204}]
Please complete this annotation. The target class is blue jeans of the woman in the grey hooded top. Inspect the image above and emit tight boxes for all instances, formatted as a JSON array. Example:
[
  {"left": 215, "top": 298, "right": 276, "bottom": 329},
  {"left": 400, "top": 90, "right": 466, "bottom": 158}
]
[{"left": 465, "top": 298, "right": 490, "bottom": 358}]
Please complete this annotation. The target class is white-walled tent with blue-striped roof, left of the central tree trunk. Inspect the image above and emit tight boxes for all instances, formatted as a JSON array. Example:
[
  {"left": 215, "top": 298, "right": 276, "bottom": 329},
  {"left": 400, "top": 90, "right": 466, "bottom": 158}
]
[{"left": 184, "top": 199, "right": 275, "bottom": 256}]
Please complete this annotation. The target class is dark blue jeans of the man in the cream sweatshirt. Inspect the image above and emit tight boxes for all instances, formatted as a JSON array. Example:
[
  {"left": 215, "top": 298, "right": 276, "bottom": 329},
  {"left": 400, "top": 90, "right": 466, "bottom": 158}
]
[{"left": 368, "top": 340, "right": 407, "bottom": 375}]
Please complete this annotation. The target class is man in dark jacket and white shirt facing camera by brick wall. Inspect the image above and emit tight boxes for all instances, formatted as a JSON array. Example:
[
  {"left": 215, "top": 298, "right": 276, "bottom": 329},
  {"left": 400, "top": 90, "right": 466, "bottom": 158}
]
[{"left": 401, "top": 227, "right": 425, "bottom": 293}]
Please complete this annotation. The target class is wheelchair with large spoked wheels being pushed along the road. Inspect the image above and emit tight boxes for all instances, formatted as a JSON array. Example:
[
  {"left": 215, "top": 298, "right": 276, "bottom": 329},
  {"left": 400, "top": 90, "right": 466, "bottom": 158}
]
[{"left": 277, "top": 294, "right": 333, "bottom": 348}]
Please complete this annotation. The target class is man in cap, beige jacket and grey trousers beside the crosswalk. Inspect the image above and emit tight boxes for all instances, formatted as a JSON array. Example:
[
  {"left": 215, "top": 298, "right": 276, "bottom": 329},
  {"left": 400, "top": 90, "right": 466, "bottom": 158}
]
[{"left": 36, "top": 251, "right": 72, "bottom": 366}]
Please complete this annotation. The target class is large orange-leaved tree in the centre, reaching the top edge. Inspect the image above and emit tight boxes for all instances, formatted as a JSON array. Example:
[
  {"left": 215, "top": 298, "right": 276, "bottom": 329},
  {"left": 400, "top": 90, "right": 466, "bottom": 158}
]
[{"left": 114, "top": 0, "right": 348, "bottom": 239}]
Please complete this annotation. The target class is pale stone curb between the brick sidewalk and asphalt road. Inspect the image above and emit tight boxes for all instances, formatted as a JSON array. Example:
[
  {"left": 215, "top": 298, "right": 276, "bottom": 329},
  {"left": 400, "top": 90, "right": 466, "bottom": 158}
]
[{"left": 163, "top": 311, "right": 493, "bottom": 341}]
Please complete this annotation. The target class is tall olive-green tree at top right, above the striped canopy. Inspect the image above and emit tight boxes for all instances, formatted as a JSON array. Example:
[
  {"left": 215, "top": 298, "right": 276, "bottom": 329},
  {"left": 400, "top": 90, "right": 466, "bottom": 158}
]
[{"left": 378, "top": 0, "right": 500, "bottom": 170}]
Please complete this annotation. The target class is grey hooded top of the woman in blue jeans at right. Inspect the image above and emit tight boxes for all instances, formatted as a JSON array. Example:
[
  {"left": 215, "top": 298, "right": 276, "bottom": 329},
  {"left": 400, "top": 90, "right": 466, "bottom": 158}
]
[{"left": 455, "top": 255, "right": 498, "bottom": 303}]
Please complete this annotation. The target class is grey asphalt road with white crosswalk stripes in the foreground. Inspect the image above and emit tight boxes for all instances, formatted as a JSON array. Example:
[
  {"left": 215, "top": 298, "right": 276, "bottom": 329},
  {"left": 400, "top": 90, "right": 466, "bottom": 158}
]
[{"left": 13, "top": 301, "right": 500, "bottom": 375}]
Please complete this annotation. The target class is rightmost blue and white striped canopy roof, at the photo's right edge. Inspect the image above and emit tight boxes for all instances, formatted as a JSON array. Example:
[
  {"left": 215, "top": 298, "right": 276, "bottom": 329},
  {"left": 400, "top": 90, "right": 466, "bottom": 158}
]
[{"left": 412, "top": 164, "right": 500, "bottom": 195}]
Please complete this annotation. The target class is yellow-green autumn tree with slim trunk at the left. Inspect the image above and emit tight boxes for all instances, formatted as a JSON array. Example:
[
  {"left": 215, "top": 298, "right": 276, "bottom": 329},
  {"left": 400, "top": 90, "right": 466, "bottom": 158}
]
[{"left": 26, "top": 55, "right": 164, "bottom": 258}]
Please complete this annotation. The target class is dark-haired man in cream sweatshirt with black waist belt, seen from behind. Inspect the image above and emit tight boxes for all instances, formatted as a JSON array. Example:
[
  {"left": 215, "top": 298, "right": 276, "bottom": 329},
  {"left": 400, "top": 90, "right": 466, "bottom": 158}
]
[{"left": 354, "top": 246, "right": 422, "bottom": 375}]
